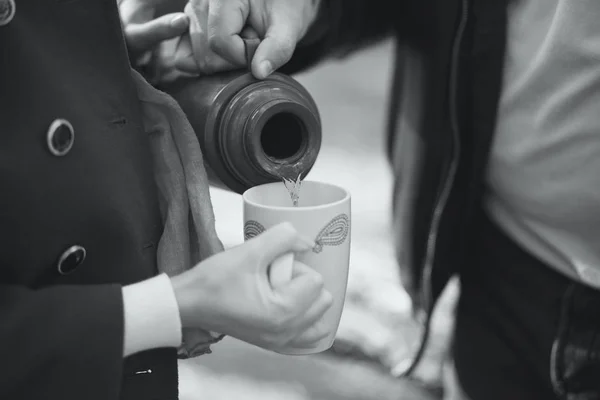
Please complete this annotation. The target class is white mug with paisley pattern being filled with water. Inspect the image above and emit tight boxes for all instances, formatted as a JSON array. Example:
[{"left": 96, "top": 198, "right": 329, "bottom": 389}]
[{"left": 243, "top": 181, "right": 350, "bottom": 355}]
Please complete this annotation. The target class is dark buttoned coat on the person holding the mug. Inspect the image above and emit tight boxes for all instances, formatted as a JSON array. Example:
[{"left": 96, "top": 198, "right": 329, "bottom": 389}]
[{"left": 0, "top": 0, "right": 177, "bottom": 400}]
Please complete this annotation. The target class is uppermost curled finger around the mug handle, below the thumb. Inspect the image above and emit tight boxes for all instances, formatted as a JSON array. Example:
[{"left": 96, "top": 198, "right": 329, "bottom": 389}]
[{"left": 273, "top": 261, "right": 323, "bottom": 310}]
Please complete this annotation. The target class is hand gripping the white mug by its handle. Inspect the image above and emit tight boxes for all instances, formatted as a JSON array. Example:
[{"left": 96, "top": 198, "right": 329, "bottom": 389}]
[{"left": 172, "top": 223, "right": 332, "bottom": 351}]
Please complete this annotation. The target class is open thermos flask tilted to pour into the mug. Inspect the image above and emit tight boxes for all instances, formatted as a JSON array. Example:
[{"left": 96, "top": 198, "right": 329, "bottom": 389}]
[{"left": 162, "top": 41, "right": 321, "bottom": 193}]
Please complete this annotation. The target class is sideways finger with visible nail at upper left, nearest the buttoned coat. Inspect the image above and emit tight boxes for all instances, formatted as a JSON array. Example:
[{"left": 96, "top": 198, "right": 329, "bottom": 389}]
[{"left": 125, "top": 13, "right": 189, "bottom": 52}]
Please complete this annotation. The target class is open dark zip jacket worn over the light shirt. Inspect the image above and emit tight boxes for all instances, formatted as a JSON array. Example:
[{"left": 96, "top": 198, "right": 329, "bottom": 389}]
[{"left": 284, "top": 0, "right": 509, "bottom": 376}]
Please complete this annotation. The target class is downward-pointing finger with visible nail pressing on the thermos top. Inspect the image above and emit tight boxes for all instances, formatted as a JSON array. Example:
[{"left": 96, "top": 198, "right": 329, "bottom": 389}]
[{"left": 252, "top": 16, "right": 299, "bottom": 79}]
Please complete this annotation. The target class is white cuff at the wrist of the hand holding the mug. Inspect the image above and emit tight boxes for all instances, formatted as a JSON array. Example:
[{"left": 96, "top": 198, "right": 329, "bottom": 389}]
[{"left": 123, "top": 274, "right": 181, "bottom": 357}]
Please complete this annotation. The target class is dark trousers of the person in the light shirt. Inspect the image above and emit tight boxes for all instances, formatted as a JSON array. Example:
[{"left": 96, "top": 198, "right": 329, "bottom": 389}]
[{"left": 453, "top": 211, "right": 600, "bottom": 400}]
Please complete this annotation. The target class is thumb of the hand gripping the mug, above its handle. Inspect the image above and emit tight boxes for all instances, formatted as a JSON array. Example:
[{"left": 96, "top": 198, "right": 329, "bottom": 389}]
[{"left": 248, "top": 222, "right": 315, "bottom": 268}]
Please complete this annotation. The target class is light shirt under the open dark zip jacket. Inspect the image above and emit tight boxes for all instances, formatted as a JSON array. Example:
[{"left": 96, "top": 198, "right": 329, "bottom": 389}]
[{"left": 487, "top": 0, "right": 600, "bottom": 287}]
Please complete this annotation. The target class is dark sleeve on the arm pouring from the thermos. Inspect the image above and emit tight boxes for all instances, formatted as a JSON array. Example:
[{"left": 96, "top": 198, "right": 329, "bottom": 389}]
[{"left": 281, "top": 0, "right": 411, "bottom": 74}]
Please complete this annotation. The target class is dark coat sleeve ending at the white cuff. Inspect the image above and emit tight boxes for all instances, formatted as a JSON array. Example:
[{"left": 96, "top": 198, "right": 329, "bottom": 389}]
[{"left": 0, "top": 284, "right": 124, "bottom": 400}]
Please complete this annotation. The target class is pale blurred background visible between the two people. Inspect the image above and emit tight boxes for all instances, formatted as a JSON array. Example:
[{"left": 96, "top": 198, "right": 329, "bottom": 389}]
[{"left": 183, "top": 43, "right": 452, "bottom": 400}]
